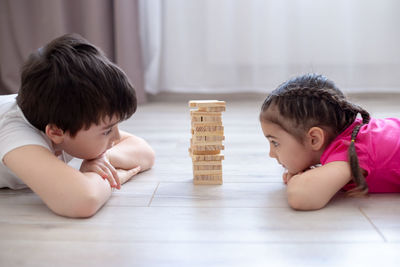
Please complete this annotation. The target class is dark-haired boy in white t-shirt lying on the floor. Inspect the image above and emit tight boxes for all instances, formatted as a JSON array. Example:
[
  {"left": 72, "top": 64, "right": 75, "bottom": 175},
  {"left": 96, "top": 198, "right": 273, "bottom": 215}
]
[{"left": 0, "top": 35, "right": 154, "bottom": 217}]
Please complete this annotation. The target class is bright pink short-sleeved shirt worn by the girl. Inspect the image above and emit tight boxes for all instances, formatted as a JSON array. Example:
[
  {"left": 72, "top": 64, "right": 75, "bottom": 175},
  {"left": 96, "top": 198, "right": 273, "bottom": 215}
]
[{"left": 321, "top": 118, "right": 400, "bottom": 193}]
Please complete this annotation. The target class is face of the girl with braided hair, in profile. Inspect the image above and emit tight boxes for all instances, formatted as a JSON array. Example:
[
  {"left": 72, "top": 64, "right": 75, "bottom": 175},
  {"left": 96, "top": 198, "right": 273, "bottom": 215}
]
[{"left": 261, "top": 121, "right": 319, "bottom": 174}]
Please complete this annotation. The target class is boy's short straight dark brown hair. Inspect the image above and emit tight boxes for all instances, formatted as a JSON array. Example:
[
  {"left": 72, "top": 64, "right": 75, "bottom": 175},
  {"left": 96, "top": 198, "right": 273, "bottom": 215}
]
[{"left": 17, "top": 34, "right": 137, "bottom": 136}]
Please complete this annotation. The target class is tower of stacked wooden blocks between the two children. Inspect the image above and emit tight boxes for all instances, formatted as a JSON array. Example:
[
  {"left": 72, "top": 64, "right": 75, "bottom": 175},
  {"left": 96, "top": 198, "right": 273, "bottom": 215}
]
[{"left": 189, "top": 100, "right": 225, "bottom": 184}]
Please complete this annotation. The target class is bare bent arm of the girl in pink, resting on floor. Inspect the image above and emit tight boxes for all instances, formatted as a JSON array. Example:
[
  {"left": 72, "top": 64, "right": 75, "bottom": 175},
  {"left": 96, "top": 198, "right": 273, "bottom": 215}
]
[{"left": 287, "top": 161, "right": 351, "bottom": 210}]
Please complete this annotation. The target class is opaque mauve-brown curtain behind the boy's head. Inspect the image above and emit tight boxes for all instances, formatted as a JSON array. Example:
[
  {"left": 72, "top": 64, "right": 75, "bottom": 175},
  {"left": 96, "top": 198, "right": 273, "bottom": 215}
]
[{"left": 0, "top": 0, "right": 146, "bottom": 103}]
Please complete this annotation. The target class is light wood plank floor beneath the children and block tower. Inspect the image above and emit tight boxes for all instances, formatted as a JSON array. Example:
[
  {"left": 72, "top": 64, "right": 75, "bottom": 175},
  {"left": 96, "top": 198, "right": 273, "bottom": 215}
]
[{"left": 0, "top": 93, "right": 400, "bottom": 267}]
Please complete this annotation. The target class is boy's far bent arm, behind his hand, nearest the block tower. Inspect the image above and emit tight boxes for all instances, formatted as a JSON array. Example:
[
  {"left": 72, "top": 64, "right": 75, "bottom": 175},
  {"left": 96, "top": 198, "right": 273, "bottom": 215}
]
[{"left": 107, "top": 131, "right": 154, "bottom": 171}]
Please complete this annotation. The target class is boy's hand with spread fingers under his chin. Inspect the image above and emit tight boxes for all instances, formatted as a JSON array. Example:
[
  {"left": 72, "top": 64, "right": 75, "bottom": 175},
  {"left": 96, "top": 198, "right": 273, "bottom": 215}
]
[{"left": 80, "top": 153, "right": 121, "bottom": 189}]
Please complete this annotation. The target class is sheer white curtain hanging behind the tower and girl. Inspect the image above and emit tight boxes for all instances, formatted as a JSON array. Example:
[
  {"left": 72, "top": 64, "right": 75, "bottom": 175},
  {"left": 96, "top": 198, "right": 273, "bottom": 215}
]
[{"left": 139, "top": 0, "right": 400, "bottom": 94}]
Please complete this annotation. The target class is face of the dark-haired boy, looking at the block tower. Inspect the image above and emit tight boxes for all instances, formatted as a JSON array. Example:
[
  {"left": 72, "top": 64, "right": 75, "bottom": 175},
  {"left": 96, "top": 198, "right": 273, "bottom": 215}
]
[{"left": 58, "top": 116, "right": 120, "bottom": 159}]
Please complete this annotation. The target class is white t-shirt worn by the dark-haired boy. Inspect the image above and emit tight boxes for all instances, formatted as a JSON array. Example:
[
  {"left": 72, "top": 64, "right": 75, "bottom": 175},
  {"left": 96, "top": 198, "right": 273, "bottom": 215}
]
[{"left": 0, "top": 94, "right": 72, "bottom": 189}]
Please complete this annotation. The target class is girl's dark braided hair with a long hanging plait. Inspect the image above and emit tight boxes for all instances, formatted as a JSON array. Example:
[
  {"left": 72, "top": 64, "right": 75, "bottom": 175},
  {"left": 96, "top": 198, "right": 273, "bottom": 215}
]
[{"left": 260, "top": 74, "right": 370, "bottom": 195}]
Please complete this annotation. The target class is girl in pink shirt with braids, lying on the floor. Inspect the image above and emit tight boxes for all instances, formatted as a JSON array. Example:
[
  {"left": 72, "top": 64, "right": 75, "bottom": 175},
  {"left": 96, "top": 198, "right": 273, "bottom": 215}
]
[{"left": 260, "top": 74, "right": 400, "bottom": 210}]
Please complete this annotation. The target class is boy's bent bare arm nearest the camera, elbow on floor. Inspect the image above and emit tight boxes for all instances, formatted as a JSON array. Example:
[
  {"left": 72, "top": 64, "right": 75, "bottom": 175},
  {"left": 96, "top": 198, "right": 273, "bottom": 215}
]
[{"left": 3, "top": 145, "right": 111, "bottom": 217}]
